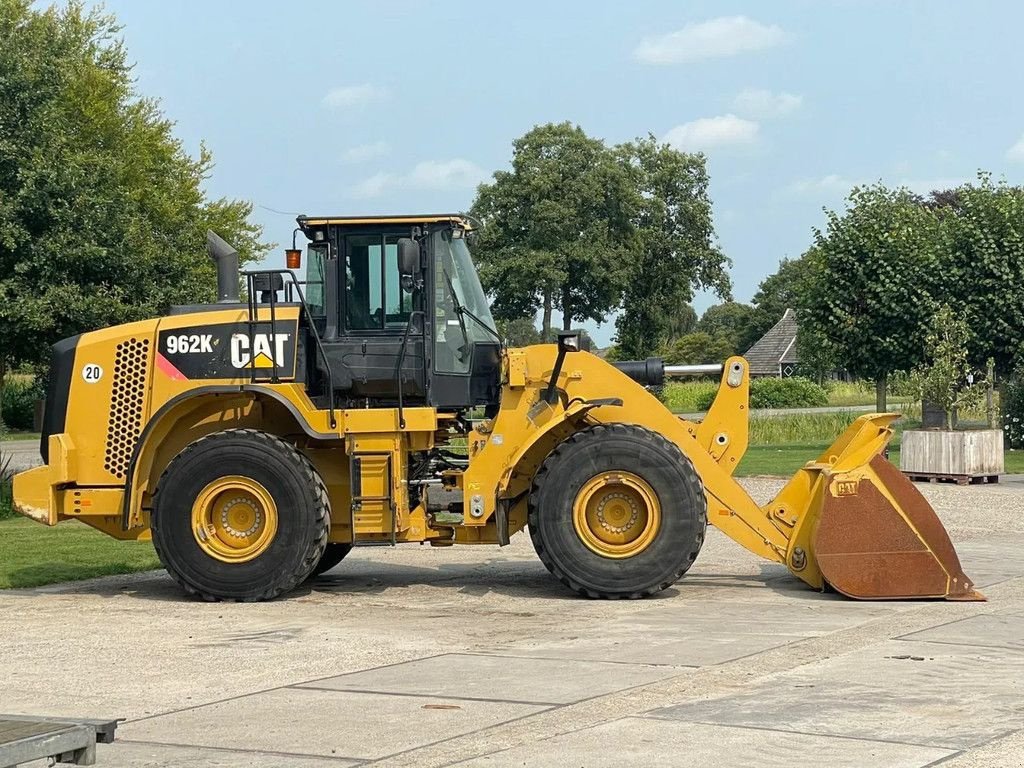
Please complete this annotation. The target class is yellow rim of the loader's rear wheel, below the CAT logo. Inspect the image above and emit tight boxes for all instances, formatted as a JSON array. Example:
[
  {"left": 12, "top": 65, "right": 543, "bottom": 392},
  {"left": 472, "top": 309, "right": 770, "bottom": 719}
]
[{"left": 191, "top": 475, "right": 278, "bottom": 563}]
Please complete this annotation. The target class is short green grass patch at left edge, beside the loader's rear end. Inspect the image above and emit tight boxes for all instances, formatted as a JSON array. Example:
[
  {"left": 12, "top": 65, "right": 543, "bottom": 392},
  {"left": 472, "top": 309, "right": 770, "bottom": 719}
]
[{"left": 0, "top": 518, "right": 160, "bottom": 589}]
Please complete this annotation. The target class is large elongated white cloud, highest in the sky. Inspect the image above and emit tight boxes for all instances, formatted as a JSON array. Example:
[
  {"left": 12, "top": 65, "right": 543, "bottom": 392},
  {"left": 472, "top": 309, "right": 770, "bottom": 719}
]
[{"left": 633, "top": 16, "right": 785, "bottom": 65}]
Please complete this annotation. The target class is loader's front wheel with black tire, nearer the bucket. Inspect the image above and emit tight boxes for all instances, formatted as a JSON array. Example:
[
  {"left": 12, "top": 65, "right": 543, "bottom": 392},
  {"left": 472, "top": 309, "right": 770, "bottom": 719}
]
[{"left": 529, "top": 424, "right": 707, "bottom": 599}]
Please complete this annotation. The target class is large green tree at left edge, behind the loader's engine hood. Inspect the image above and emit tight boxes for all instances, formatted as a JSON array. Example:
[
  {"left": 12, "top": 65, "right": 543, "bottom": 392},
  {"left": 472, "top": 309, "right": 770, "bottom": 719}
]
[{"left": 0, "top": 0, "right": 266, "bottom": 423}]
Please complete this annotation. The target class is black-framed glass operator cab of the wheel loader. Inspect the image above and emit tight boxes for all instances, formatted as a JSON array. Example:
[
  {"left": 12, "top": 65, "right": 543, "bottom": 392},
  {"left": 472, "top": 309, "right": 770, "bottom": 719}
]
[{"left": 298, "top": 214, "right": 501, "bottom": 410}]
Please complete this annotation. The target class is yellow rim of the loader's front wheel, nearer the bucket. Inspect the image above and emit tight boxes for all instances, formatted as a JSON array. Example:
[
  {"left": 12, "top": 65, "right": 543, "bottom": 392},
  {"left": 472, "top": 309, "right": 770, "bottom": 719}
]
[{"left": 572, "top": 472, "right": 662, "bottom": 558}]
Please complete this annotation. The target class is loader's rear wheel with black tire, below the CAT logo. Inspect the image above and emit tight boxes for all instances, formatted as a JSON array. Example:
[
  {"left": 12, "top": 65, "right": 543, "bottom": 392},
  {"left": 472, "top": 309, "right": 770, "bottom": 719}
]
[{"left": 151, "top": 429, "right": 331, "bottom": 602}]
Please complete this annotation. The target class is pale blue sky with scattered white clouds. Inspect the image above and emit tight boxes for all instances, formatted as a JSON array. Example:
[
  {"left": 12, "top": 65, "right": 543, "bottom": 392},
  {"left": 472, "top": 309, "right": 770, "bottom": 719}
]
[{"left": 92, "top": 0, "right": 1024, "bottom": 345}]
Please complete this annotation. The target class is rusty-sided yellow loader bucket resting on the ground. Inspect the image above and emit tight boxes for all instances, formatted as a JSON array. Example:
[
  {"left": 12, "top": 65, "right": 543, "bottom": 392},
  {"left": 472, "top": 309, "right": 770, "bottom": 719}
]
[{"left": 769, "top": 414, "right": 985, "bottom": 600}]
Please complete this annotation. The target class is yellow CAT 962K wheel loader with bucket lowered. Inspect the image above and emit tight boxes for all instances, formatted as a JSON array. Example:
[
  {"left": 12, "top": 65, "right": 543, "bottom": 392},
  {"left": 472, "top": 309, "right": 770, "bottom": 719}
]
[{"left": 14, "top": 215, "right": 983, "bottom": 600}]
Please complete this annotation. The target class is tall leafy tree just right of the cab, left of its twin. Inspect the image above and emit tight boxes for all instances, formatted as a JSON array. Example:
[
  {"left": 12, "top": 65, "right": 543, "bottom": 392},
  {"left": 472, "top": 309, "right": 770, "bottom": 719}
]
[{"left": 472, "top": 123, "right": 632, "bottom": 338}]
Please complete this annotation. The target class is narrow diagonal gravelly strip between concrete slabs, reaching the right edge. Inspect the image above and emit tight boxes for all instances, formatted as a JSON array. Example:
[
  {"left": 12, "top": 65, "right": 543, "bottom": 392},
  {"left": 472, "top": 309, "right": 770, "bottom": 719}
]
[{"left": 366, "top": 577, "right": 1024, "bottom": 768}]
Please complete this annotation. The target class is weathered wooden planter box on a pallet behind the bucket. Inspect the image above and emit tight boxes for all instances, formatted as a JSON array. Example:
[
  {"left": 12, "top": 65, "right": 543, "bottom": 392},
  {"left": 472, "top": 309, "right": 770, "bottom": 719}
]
[{"left": 899, "top": 429, "right": 1005, "bottom": 483}]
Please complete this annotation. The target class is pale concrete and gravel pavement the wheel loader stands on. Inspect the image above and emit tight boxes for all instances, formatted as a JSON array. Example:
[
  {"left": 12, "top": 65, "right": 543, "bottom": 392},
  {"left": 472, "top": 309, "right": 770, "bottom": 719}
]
[{"left": 0, "top": 479, "right": 1024, "bottom": 768}]
